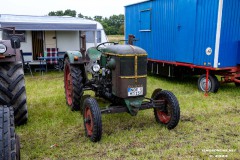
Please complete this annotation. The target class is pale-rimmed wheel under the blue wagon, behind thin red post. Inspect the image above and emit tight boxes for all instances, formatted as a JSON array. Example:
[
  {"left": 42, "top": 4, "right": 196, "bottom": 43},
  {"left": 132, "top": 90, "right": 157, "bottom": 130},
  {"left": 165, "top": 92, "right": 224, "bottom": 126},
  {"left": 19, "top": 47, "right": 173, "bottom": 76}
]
[{"left": 198, "top": 74, "right": 220, "bottom": 93}]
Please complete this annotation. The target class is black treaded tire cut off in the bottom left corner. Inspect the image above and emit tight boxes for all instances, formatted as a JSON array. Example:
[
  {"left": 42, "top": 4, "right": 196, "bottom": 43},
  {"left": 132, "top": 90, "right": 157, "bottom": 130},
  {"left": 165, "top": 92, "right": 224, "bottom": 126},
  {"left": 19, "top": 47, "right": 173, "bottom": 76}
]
[{"left": 0, "top": 105, "right": 20, "bottom": 160}]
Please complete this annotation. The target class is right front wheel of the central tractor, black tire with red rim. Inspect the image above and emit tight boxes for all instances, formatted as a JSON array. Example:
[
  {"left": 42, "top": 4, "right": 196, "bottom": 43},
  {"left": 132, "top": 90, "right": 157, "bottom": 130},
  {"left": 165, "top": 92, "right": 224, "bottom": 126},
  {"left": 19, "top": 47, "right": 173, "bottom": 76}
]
[{"left": 152, "top": 90, "right": 180, "bottom": 130}]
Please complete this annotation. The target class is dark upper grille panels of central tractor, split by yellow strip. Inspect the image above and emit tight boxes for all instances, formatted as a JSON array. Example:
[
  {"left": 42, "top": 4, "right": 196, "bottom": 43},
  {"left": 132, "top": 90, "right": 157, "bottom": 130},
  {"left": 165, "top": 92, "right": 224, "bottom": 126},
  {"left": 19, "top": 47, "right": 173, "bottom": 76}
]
[{"left": 120, "top": 56, "right": 147, "bottom": 76}]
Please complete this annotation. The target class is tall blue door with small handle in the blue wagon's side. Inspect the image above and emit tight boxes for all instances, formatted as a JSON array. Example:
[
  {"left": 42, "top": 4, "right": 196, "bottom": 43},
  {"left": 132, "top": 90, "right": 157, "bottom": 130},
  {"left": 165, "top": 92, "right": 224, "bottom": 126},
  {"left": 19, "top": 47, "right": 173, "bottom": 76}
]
[{"left": 175, "top": 0, "right": 197, "bottom": 63}]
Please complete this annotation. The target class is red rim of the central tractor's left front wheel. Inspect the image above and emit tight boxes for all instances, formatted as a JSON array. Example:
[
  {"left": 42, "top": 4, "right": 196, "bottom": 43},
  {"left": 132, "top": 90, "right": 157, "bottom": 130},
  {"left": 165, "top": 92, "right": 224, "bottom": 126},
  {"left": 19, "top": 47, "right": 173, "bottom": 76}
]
[{"left": 84, "top": 106, "right": 93, "bottom": 136}]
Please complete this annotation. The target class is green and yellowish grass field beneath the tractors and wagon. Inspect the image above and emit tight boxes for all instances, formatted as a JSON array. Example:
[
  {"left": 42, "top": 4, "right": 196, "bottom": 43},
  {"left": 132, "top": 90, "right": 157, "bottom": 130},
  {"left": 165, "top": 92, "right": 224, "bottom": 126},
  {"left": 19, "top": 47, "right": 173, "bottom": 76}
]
[{"left": 16, "top": 72, "right": 240, "bottom": 160}]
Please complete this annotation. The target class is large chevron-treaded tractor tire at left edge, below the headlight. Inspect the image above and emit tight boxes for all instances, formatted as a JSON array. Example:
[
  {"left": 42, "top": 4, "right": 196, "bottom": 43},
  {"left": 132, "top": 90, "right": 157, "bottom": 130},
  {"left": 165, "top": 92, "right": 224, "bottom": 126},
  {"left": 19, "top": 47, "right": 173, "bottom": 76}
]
[{"left": 0, "top": 62, "right": 28, "bottom": 125}]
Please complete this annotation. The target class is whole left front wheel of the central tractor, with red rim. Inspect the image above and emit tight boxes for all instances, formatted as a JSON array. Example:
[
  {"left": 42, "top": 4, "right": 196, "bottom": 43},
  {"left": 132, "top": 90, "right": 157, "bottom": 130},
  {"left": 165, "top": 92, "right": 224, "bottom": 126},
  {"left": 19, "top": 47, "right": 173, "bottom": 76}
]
[{"left": 83, "top": 97, "right": 102, "bottom": 142}]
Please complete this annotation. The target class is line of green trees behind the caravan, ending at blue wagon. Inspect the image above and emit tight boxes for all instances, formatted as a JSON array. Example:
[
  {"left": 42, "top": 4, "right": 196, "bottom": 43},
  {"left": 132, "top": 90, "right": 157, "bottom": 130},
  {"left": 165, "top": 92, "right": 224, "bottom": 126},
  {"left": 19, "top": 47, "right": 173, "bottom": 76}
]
[{"left": 48, "top": 9, "right": 124, "bottom": 35}]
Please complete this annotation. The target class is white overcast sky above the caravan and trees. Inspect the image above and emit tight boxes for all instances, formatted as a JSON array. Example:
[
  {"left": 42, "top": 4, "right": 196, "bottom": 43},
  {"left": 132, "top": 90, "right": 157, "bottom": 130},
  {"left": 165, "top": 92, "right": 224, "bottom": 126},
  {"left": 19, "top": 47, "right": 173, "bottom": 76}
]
[{"left": 0, "top": 0, "right": 144, "bottom": 17}]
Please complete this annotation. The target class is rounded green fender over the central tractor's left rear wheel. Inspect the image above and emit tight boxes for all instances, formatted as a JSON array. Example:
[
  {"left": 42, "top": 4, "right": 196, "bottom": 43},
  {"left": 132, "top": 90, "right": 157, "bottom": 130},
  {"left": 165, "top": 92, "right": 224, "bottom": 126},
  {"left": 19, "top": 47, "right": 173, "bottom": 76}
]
[{"left": 64, "top": 51, "right": 83, "bottom": 64}]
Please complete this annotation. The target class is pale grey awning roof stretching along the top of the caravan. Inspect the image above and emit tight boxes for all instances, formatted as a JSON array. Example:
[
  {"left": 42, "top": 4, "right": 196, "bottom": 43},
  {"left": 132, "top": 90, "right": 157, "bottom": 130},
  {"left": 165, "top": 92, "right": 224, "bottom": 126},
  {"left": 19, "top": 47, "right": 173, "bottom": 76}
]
[{"left": 0, "top": 14, "right": 97, "bottom": 31}]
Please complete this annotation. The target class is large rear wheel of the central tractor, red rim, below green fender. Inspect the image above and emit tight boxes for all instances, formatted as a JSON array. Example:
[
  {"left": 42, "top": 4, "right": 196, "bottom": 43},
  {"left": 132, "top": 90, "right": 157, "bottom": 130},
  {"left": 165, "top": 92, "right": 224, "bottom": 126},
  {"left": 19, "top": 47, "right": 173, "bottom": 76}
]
[{"left": 64, "top": 58, "right": 83, "bottom": 111}]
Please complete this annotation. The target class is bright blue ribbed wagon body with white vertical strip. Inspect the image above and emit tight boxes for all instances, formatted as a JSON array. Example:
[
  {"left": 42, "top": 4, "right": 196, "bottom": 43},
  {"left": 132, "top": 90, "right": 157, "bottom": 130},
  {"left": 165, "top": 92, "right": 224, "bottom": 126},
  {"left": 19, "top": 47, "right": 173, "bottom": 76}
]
[{"left": 125, "top": 0, "right": 240, "bottom": 68}]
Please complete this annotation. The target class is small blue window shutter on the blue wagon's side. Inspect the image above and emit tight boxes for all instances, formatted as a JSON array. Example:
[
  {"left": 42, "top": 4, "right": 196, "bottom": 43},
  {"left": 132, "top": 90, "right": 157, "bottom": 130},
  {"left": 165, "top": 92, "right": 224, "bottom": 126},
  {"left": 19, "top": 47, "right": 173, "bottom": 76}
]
[{"left": 140, "top": 9, "right": 151, "bottom": 32}]
